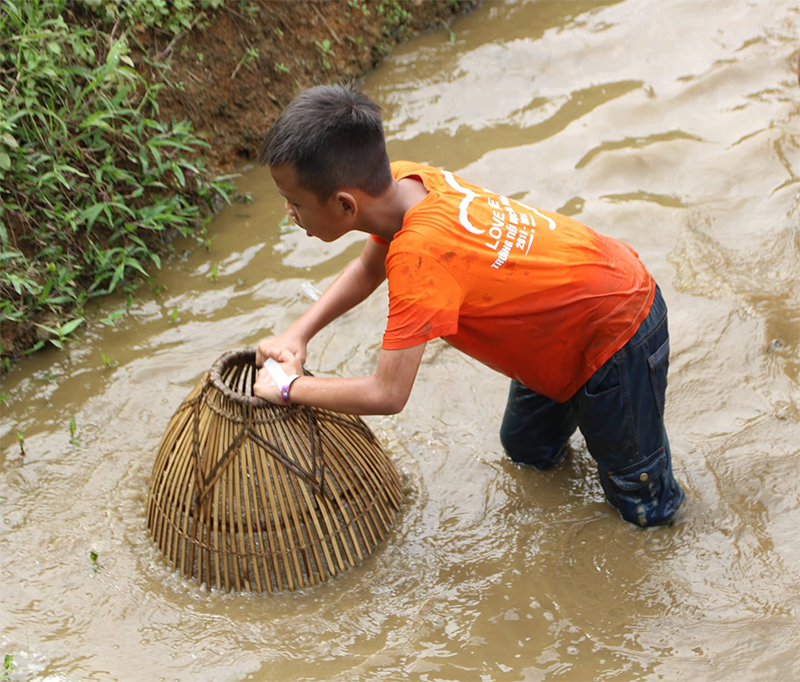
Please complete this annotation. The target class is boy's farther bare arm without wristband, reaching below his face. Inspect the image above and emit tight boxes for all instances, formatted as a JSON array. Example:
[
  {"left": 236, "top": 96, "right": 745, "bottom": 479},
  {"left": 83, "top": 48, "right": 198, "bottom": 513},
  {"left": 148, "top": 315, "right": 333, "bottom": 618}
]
[{"left": 256, "top": 238, "right": 389, "bottom": 367}]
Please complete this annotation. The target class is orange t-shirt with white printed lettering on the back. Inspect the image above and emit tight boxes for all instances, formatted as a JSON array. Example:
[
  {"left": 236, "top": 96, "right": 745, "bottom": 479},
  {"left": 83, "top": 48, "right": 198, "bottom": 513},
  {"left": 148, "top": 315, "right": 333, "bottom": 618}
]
[{"left": 383, "top": 161, "right": 655, "bottom": 402}]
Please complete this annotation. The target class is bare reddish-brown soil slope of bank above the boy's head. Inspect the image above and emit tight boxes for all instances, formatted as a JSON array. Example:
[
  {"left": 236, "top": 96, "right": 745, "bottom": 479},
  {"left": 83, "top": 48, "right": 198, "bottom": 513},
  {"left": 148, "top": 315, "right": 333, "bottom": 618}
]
[{"left": 141, "top": 0, "right": 479, "bottom": 169}]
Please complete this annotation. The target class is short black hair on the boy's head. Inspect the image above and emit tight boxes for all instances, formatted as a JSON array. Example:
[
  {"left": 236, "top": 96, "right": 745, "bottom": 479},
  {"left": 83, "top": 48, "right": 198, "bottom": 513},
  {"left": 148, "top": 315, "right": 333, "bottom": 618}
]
[{"left": 258, "top": 85, "right": 392, "bottom": 201}]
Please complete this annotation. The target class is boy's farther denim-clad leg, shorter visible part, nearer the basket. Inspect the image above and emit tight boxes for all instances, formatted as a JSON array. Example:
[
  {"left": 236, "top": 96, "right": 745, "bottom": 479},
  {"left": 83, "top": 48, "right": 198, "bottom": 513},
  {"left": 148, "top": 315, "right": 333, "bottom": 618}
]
[{"left": 500, "top": 381, "right": 578, "bottom": 469}]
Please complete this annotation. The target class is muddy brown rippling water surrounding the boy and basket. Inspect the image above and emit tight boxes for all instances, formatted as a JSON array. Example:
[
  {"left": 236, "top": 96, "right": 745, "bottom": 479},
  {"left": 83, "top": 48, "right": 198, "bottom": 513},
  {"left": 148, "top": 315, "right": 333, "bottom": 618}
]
[{"left": 0, "top": 0, "right": 800, "bottom": 682}]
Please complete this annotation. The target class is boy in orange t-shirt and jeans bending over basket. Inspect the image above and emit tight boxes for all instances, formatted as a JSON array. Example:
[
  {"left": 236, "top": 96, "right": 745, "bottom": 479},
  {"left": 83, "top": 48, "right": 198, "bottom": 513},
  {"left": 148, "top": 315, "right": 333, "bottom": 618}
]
[{"left": 255, "top": 86, "right": 683, "bottom": 526}]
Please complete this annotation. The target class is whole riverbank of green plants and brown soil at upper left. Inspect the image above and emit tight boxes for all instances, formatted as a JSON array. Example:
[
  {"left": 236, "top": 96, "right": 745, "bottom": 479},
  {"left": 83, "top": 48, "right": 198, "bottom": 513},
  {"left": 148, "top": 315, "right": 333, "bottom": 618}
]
[{"left": 0, "top": 0, "right": 478, "bottom": 373}]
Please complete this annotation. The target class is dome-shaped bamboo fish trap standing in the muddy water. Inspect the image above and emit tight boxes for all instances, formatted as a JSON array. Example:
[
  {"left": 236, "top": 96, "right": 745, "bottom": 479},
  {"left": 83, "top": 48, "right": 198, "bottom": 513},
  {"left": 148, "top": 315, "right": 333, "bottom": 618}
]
[{"left": 147, "top": 350, "right": 402, "bottom": 592}]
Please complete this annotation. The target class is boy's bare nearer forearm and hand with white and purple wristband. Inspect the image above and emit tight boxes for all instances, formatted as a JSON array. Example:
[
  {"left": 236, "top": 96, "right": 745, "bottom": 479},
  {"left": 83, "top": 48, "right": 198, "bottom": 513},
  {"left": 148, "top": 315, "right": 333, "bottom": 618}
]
[{"left": 254, "top": 340, "right": 425, "bottom": 414}]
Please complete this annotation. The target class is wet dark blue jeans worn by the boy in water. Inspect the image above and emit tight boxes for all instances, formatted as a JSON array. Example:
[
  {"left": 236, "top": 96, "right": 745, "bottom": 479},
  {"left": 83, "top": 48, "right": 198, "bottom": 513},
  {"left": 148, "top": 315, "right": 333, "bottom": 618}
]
[{"left": 500, "top": 287, "right": 684, "bottom": 526}]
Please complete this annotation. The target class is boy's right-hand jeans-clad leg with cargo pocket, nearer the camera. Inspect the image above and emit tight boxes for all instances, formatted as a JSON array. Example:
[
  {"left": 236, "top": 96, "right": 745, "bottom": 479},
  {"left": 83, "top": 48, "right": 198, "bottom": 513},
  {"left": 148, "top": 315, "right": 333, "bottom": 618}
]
[{"left": 570, "top": 289, "right": 684, "bottom": 526}]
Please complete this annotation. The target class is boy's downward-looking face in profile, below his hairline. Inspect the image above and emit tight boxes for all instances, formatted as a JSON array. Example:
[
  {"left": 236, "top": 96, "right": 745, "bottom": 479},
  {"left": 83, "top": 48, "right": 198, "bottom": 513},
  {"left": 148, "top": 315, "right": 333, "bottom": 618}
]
[{"left": 269, "top": 164, "right": 350, "bottom": 242}]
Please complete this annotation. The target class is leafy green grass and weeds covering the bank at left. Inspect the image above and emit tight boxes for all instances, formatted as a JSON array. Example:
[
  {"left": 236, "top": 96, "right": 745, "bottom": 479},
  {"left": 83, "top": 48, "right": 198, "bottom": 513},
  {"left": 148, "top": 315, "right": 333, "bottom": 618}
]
[{"left": 0, "top": 0, "right": 233, "bottom": 355}]
